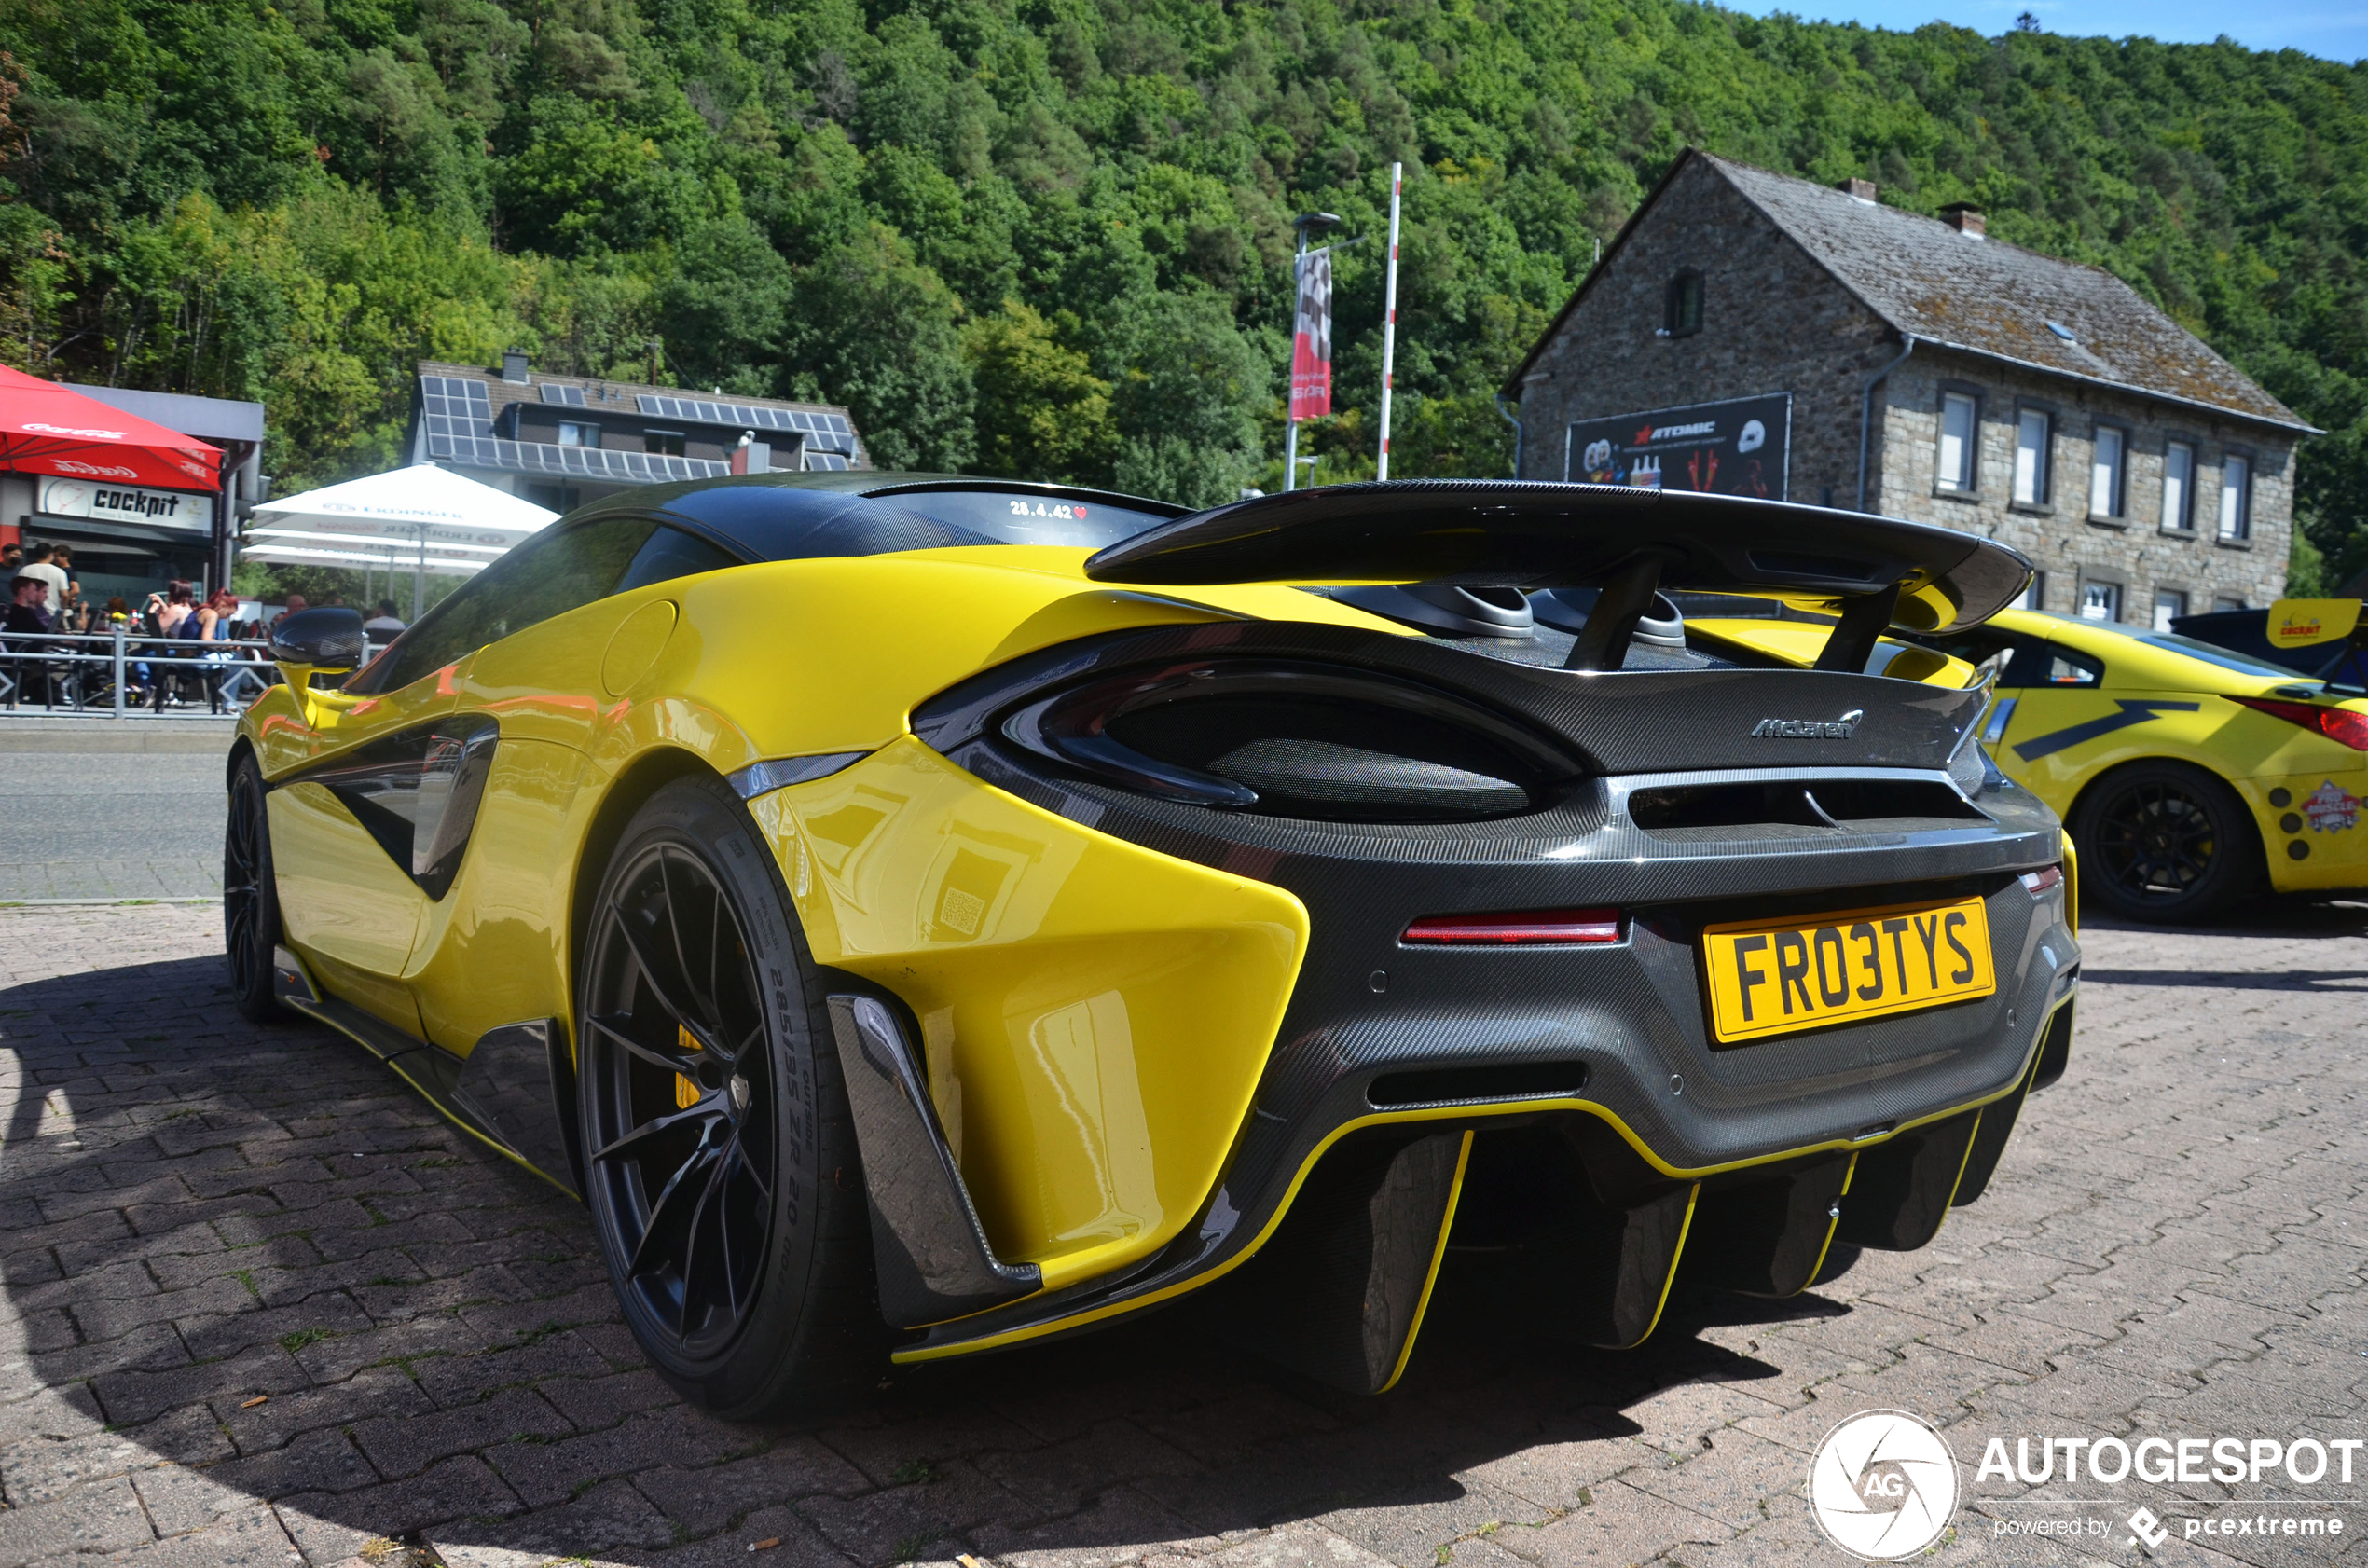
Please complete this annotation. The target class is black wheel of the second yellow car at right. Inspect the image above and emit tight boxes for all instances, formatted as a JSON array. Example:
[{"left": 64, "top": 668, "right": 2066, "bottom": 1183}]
[{"left": 2072, "top": 763, "right": 2262, "bottom": 924}]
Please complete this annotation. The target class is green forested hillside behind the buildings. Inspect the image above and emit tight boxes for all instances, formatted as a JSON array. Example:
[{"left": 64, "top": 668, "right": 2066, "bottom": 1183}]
[{"left": 0, "top": 0, "right": 2368, "bottom": 575}]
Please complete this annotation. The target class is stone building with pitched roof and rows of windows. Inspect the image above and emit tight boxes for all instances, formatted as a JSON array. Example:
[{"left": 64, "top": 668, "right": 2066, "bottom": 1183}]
[{"left": 1504, "top": 152, "right": 2319, "bottom": 626}]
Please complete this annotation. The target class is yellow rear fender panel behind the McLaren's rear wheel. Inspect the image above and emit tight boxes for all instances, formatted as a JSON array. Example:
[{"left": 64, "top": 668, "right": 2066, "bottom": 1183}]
[{"left": 750, "top": 736, "right": 1307, "bottom": 1288}]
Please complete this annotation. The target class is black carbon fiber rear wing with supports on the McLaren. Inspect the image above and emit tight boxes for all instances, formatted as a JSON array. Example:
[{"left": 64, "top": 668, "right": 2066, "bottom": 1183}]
[{"left": 1084, "top": 478, "right": 2031, "bottom": 670}]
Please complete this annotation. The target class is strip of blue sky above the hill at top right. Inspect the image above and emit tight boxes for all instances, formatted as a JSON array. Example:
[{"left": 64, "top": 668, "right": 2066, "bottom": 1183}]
[{"left": 1728, "top": 0, "right": 2368, "bottom": 64}]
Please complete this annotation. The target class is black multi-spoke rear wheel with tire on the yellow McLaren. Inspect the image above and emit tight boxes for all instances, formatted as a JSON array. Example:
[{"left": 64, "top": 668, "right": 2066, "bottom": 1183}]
[{"left": 575, "top": 779, "right": 881, "bottom": 1419}]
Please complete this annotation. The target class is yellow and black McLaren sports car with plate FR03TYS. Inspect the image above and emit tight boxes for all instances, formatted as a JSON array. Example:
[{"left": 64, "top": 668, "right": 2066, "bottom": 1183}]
[{"left": 223, "top": 474, "right": 2079, "bottom": 1416}]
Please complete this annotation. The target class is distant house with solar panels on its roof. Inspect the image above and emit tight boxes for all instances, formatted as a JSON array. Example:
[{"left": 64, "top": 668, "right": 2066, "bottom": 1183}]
[{"left": 412, "top": 351, "right": 872, "bottom": 512}]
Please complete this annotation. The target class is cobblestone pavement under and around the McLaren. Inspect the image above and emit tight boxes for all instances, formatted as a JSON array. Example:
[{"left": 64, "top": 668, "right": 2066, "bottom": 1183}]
[{"left": 0, "top": 907, "right": 2368, "bottom": 1568}]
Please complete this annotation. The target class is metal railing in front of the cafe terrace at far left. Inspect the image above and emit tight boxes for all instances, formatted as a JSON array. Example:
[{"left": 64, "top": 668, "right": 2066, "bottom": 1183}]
[{"left": 0, "top": 630, "right": 280, "bottom": 718}]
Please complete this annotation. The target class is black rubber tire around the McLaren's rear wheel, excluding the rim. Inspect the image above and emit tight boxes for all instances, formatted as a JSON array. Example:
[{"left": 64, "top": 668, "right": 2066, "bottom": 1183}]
[{"left": 575, "top": 779, "right": 838, "bottom": 1414}]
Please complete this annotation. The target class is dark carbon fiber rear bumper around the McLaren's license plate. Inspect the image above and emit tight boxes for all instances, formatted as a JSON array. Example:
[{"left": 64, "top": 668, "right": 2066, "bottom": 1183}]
[{"left": 852, "top": 741, "right": 2079, "bottom": 1359}]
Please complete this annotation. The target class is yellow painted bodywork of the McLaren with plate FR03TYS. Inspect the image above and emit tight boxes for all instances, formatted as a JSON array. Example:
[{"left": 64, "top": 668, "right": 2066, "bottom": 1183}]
[{"left": 241, "top": 544, "right": 2084, "bottom": 1369}]
